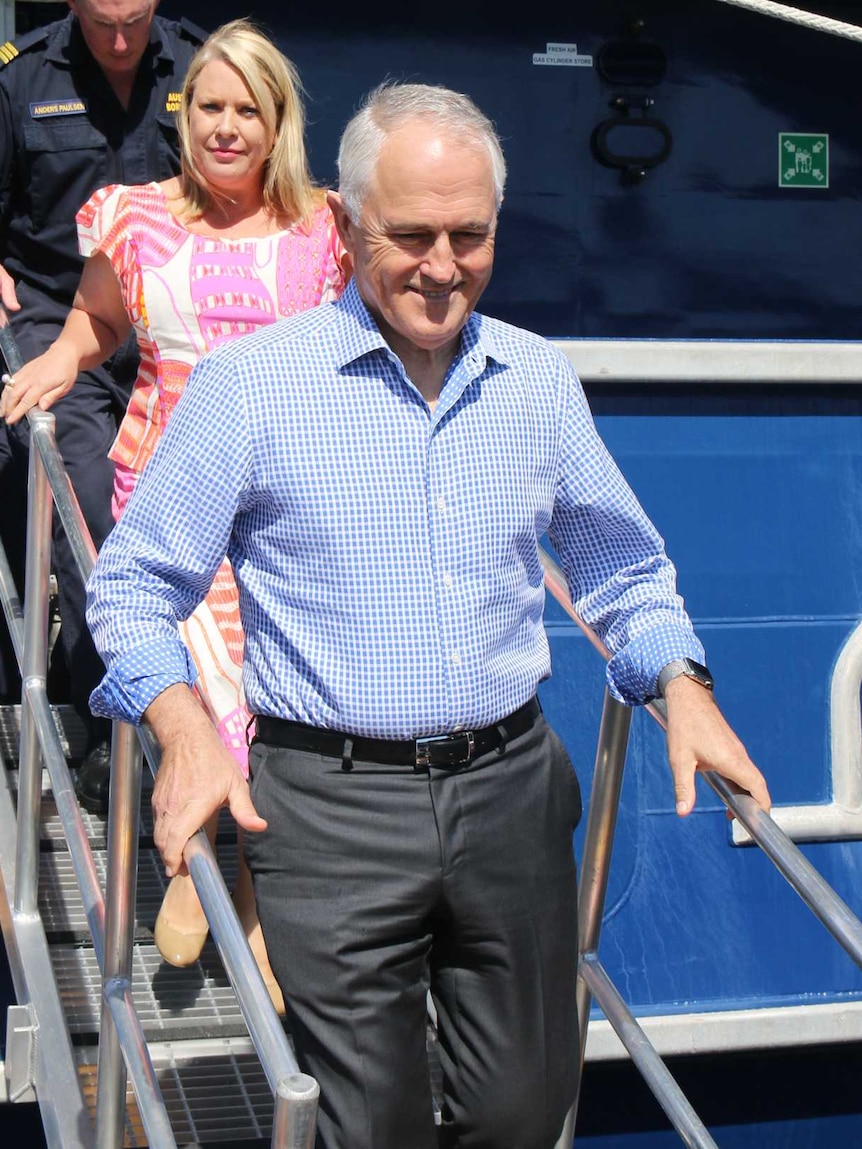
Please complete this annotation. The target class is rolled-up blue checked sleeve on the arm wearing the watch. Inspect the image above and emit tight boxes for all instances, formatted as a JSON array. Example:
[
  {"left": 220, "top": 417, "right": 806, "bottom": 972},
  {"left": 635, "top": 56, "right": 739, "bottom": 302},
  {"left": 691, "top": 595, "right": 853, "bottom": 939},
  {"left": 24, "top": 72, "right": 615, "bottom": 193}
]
[{"left": 548, "top": 364, "right": 705, "bottom": 705}]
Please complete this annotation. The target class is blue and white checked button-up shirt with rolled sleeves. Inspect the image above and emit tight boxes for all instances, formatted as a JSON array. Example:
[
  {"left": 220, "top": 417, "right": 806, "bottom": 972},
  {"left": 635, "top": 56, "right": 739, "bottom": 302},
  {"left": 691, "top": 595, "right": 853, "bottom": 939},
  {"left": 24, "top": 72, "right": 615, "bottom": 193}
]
[{"left": 87, "top": 284, "right": 703, "bottom": 738}]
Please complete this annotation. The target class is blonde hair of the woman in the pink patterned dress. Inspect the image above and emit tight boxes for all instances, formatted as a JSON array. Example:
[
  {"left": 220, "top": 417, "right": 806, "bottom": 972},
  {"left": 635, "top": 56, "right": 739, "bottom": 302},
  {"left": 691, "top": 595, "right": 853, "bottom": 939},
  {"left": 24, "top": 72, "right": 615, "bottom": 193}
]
[{"left": 177, "top": 20, "right": 323, "bottom": 222}]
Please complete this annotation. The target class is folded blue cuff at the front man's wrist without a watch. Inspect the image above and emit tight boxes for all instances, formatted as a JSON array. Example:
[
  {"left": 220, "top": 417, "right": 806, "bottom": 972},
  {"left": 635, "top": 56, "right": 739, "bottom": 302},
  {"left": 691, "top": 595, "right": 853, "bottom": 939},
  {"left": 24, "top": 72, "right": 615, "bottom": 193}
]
[{"left": 90, "top": 640, "right": 198, "bottom": 726}]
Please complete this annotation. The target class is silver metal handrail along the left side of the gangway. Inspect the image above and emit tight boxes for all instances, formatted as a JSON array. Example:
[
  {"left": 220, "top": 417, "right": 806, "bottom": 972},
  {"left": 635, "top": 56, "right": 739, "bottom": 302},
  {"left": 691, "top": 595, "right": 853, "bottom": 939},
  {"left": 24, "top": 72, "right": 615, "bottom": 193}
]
[{"left": 0, "top": 306, "right": 320, "bottom": 1149}]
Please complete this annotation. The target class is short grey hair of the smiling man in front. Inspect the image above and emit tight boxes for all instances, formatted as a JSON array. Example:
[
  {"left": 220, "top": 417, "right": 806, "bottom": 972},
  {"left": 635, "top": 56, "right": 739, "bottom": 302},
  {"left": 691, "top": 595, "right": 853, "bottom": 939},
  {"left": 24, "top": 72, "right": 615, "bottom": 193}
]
[{"left": 338, "top": 80, "right": 506, "bottom": 223}]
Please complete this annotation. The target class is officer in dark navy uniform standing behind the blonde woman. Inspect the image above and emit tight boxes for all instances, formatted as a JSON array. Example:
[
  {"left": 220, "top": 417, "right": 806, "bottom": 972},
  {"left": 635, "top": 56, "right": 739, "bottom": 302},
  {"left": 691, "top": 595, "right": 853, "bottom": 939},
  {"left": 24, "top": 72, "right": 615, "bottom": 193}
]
[{"left": 0, "top": 0, "right": 206, "bottom": 810}]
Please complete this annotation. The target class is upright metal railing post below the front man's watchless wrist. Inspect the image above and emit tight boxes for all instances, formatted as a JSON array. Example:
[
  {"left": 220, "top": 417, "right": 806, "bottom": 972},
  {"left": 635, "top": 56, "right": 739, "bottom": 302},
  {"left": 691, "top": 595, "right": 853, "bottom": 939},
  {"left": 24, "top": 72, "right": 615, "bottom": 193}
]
[{"left": 95, "top": 723, "right": 143, "bottom": 1149}]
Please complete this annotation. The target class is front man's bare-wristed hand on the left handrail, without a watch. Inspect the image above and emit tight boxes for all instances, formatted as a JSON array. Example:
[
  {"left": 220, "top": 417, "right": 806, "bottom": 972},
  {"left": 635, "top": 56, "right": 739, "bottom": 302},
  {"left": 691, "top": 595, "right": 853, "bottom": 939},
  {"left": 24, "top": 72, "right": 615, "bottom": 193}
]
[{"left": 144, "top": 685, "right": 267, "bottom": 878}]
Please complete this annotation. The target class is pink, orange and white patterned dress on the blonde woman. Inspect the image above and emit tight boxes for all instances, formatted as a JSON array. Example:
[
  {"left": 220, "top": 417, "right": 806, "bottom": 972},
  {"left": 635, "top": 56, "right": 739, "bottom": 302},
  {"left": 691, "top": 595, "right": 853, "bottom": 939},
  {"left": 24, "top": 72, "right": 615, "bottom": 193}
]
[{"left": 77, "top": 184, "right": 345, "bottom": 773}]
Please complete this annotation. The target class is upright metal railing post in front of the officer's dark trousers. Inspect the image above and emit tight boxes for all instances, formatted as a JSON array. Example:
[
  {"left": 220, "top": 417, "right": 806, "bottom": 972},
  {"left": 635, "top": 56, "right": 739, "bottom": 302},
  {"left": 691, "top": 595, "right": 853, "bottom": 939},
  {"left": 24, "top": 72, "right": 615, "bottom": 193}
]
[{"left": 15, "top": 411, "right": 54, "bottom": 915}]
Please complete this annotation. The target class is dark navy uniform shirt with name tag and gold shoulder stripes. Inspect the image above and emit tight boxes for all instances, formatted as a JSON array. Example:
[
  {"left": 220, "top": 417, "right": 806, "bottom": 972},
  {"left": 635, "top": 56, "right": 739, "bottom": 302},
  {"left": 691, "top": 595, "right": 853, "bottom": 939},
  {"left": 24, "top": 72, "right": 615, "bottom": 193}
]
[{"left": 0, "top": 14, "right": 205, "bottom": 323}]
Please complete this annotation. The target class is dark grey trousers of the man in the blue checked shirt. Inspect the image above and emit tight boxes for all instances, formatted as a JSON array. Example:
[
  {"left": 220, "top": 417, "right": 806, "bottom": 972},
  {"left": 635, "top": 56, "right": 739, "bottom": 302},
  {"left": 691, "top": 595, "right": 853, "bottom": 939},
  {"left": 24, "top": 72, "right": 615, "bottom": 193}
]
[{"left": 246, "top": 716, "right": 580, "bottom": 1149}]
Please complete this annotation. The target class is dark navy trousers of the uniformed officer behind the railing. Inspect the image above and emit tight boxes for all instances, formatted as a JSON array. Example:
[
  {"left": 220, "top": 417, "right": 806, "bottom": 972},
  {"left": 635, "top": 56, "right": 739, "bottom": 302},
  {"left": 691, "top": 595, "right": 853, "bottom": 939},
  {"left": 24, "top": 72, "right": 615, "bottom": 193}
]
[{"left": 0, "top": 305, "right": 137, "bottom": 742}]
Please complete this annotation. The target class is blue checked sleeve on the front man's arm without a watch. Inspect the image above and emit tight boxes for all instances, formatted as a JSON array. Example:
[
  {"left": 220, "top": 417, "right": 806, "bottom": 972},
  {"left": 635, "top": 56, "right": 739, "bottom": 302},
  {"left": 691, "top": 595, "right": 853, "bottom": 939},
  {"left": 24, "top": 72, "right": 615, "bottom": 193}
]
[{"left": 87, "top": 352, "right": 251, "bottom": 724}]
